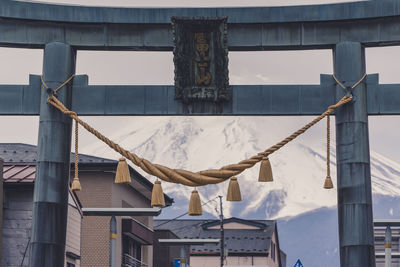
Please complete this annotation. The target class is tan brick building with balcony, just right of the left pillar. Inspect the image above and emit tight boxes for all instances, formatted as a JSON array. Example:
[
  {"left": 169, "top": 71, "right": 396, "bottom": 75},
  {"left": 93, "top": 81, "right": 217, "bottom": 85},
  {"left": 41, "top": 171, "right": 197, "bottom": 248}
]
[{"left": 77, "top": 161, "right": 173, "bottom": 267}]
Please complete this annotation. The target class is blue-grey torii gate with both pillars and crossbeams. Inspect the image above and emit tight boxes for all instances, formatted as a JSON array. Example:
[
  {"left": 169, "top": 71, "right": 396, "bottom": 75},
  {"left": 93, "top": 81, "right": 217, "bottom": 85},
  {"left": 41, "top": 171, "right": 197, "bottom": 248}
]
[{"left": 0, "top": 0, "right": 400, "bottom": 267}]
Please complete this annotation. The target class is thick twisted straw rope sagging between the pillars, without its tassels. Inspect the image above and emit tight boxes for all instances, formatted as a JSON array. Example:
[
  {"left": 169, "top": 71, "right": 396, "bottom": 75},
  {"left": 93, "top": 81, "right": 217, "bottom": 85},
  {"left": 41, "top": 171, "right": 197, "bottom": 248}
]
[{"left": 42, "top": 75, "right": 365, "bottom": 187}]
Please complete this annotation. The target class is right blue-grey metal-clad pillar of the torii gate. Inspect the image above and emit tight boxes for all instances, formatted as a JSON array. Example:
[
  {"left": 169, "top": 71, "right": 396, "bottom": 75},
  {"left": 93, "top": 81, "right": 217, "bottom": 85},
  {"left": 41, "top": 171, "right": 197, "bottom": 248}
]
[{"left": 334, "top": 42, "right": 375, "bottom": 267}]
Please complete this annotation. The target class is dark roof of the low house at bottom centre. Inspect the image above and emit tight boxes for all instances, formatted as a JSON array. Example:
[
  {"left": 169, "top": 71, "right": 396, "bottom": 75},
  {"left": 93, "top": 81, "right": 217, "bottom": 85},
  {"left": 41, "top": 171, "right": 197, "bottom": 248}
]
[{"left": 154, "top": 218, "right": 276, "bottom": 255}]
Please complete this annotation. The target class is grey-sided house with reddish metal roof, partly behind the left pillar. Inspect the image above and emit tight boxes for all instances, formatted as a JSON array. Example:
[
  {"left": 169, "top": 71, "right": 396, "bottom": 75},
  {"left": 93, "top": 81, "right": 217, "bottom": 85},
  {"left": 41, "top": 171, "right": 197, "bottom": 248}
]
[{"left": 0, "top": 144, "right": 82, "bottom": 267}]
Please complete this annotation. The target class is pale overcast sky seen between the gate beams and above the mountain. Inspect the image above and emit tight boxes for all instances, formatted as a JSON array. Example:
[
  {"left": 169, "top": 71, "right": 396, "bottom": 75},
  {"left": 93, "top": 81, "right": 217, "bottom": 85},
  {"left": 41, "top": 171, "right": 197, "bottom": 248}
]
[{"left": 0, "top": 0, "right": 400, "bottom": 162}]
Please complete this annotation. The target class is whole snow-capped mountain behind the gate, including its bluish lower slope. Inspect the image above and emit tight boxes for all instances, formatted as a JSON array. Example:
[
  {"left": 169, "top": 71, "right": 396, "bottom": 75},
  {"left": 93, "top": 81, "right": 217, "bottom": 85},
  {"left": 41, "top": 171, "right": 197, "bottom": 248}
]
[{"left": 82, "top": 117, "right": 400, "bottom": 267}]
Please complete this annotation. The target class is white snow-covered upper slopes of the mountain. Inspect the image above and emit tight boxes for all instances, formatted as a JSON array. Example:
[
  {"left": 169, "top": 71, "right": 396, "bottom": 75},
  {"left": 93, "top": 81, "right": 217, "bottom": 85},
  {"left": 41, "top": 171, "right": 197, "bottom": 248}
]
[{"left": 82, "top": 117, "right": 400, "bottom": 219}]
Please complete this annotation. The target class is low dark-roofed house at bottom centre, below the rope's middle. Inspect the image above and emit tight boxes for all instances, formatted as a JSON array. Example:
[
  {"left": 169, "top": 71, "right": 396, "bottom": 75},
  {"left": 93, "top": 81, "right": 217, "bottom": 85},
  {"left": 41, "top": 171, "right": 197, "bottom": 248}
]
[{"left": 153, "top": 217, "right": 286, "bottom": 267}]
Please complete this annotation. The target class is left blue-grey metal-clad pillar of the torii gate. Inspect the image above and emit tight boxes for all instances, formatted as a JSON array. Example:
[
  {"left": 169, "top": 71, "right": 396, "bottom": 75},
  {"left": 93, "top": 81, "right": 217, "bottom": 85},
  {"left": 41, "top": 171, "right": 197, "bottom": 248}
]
[{"left": 29, "top": 43, "right": 75, "bottom": 267}]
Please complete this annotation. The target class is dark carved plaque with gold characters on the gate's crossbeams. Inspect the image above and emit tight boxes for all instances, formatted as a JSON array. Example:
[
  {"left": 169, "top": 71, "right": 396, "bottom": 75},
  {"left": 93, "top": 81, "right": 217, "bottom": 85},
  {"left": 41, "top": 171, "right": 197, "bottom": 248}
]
[{"left": 171, "top": 17, "right": 231, "bottom": 103}]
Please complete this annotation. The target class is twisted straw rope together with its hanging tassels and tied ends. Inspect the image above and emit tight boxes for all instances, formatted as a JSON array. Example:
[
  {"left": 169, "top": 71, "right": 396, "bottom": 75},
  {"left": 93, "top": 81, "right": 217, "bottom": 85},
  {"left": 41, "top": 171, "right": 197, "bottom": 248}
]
[{"left": 41, "top": 74, "right": 366, "bottom": 215}]
